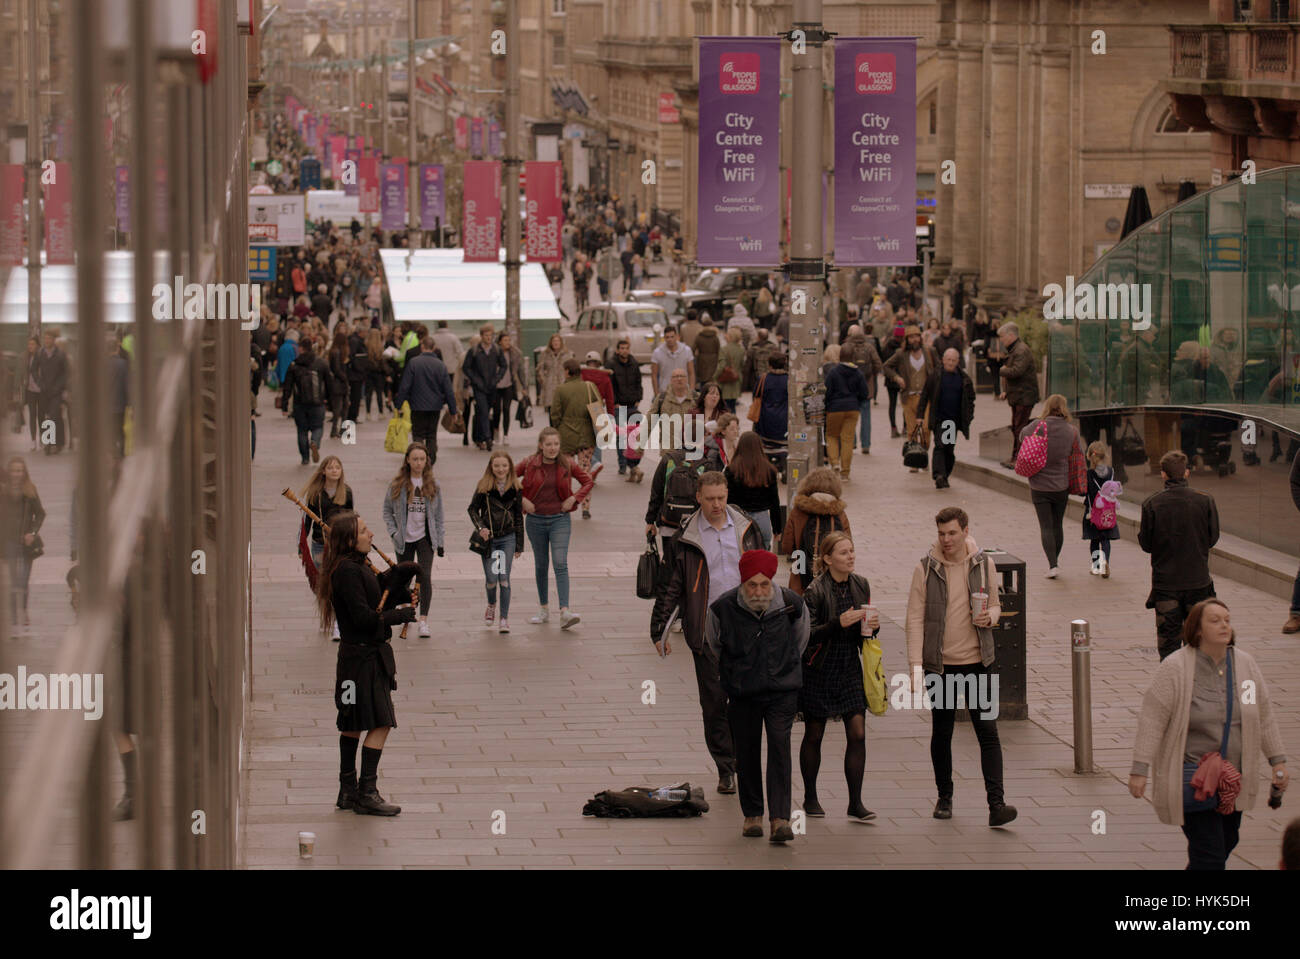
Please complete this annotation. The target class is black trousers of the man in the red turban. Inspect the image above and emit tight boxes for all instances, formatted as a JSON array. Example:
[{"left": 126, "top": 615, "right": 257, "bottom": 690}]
[{"left": 727, "top": 690, "right": 800, "bottom": 819}]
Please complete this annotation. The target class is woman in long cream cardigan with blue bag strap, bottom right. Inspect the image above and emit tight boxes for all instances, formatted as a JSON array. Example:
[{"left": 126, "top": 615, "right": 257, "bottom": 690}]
[{"left": 1128, "top": 597, "right": 1290, "bottom": 871}]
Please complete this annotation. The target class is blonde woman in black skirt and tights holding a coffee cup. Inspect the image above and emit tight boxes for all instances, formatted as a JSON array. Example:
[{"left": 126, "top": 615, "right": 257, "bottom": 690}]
[{"left": 800, "top": 530, "right": 880, "bottom": 823}]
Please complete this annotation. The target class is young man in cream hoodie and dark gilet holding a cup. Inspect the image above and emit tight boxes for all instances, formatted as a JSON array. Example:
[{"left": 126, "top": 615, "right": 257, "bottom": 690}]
[{"left": 906, "top": 507, "right": 1015, "bottom": 826}]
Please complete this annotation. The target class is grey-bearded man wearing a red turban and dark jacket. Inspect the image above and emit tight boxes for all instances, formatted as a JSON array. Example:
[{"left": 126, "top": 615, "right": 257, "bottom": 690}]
[{"left": 705, "top": 550, "right": 809, "bottom": 842}]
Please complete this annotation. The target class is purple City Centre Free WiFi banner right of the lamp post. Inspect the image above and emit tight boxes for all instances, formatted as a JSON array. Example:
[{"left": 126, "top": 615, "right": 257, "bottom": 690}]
[{"left": 835, "top": 36, "right": 917, "bottom": 266}]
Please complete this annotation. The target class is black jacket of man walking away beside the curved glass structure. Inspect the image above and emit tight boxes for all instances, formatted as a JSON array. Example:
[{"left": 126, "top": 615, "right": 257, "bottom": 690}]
[{"left": 1138, "top": 478, "right": 1219, "bottom": 593}]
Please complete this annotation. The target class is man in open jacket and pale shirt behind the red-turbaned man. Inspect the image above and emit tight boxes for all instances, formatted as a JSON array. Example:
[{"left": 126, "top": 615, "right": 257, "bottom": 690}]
[{"left": 650, "top": 472, "right": 763, "bottom": 794}]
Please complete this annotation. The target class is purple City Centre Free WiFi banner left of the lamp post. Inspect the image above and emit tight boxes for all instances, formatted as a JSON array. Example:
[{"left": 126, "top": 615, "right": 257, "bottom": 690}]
[{"left": 696, "top": 38, "right": 781, "bottom": 266}]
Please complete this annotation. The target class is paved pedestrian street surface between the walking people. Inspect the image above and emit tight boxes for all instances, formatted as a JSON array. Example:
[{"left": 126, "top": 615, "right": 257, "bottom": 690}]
[{"left": 244, "top": 320, "right": 1300, "bottom": 869}]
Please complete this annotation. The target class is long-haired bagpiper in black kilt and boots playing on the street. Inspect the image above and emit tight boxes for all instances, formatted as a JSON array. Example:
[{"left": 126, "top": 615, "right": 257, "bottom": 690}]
[{"left": 317, "top": 511, "right": 419, "bottom": 816}]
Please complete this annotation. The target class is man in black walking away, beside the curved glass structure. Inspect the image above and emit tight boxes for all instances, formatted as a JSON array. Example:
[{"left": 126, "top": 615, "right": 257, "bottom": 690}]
[{"left": 1138, "top": 450, "right": 1219, "bottom": 659}]
